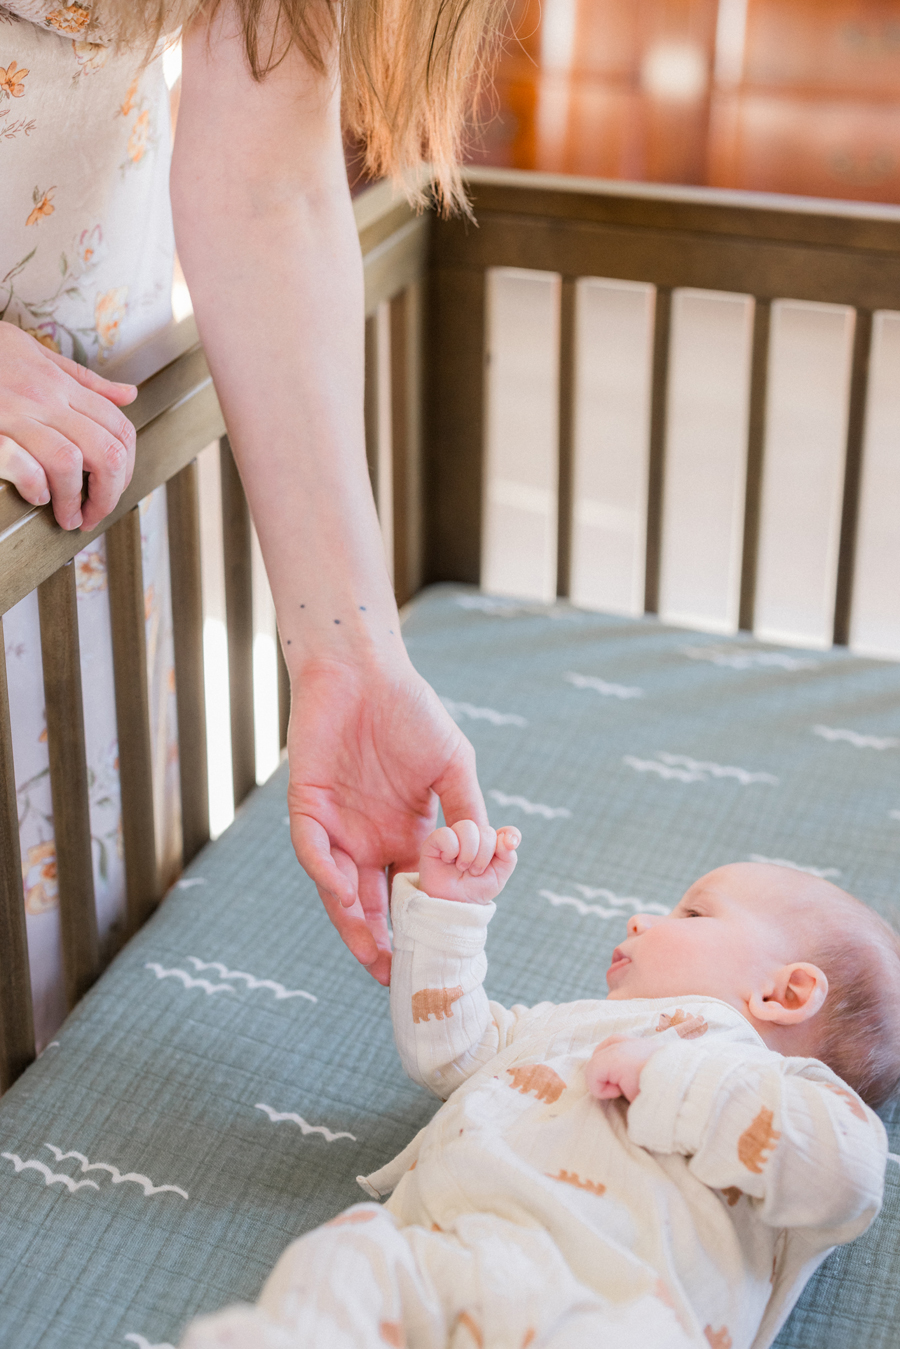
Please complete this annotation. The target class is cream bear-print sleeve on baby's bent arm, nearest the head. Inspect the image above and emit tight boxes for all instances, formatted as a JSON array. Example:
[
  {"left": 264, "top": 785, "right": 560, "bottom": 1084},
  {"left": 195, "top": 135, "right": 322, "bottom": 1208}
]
[{"left": 627, "top": 1041, "right": 888, "bottom": 1245}]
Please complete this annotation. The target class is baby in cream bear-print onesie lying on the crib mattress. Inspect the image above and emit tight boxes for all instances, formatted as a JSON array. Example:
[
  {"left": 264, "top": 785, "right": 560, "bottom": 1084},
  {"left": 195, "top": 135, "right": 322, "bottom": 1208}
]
[{"left": 185, "top": 820, "right": 900, "bottom": 1349}]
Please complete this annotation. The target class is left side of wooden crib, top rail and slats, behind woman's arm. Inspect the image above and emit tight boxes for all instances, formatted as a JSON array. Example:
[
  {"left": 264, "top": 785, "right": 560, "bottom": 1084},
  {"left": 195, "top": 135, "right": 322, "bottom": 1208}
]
[{"left": 0, "top": 186, "right": 428, "bottom": 1090}]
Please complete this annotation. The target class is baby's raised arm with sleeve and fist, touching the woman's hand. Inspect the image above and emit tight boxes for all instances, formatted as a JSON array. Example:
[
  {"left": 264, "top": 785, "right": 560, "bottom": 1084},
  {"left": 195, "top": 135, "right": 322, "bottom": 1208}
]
[{"left": 390, "top": 822, "right": 519, "bottom": 1099}]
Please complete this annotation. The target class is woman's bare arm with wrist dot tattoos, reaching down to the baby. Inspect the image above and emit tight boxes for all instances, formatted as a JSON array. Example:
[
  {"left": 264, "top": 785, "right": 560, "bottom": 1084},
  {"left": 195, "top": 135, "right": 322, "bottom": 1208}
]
[{"left": 173, "top": 7, "right": 487, "bottom": 983}]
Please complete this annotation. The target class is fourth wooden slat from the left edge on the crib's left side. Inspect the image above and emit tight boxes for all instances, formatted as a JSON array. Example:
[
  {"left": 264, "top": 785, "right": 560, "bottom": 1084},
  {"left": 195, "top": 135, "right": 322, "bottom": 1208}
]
[{"left": 166, "top": 459, "right": 209, "bottom": 866}]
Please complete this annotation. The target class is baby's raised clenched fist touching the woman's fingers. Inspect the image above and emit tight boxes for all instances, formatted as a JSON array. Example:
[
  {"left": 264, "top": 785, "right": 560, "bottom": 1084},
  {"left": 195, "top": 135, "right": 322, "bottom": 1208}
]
[{"left": 418, "top": 820, "right": 522, "bottom": 904}]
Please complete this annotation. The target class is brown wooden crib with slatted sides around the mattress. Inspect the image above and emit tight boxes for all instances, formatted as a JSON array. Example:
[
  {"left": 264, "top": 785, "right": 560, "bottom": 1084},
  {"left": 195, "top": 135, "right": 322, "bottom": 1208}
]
[{"left": 0, "top": 170, "right": 900, "bottom": 1089}]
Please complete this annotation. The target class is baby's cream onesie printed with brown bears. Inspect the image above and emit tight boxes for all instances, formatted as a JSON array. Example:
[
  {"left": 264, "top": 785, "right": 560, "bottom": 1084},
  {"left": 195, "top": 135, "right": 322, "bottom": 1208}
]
[{"left": 185, "top": 876, "right": 887, "bottom": 1349}]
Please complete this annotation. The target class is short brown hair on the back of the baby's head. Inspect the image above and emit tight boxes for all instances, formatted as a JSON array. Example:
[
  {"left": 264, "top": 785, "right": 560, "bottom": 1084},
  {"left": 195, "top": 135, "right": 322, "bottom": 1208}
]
[{"left": 812, "top": 896, "right": 900, "bottom": 1108}]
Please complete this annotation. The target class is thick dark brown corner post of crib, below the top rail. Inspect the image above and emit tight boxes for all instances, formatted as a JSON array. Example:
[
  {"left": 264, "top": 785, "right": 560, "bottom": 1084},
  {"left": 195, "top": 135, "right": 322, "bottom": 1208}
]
[{"left": 422, "top": 267, "right": 484, "bottom": 585}]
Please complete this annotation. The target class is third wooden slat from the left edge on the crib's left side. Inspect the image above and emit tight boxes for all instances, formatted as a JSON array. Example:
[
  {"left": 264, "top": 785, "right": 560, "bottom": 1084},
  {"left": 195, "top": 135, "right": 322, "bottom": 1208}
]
[{"left": 107, "top": 506, "right": 161, "bottom": 935}]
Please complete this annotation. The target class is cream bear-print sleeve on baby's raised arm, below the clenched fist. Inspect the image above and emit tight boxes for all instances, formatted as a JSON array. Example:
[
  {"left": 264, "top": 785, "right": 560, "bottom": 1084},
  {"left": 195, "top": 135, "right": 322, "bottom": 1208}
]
[{"left": 390, "top": 873, "right": 536, "bottom": 1101}]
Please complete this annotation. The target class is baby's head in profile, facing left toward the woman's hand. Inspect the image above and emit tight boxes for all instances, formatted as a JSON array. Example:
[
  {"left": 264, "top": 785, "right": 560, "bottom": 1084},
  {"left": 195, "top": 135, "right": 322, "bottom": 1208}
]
[{"left": 607, "top": 862, "right": 900, "bottom": 1105}]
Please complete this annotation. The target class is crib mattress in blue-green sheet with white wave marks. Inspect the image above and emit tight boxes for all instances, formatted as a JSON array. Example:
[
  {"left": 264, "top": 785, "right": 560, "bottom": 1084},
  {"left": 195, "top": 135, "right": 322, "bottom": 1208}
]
[{"left": 0, "top": 587, "right": 900, "bottom": 1349}]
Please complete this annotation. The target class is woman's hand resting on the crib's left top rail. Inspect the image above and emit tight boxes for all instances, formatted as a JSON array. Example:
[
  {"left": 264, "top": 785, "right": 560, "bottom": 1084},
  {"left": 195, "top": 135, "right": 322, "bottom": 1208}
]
[{"left": 0, "top": 322, "right": 138, "bottom": 530}]
